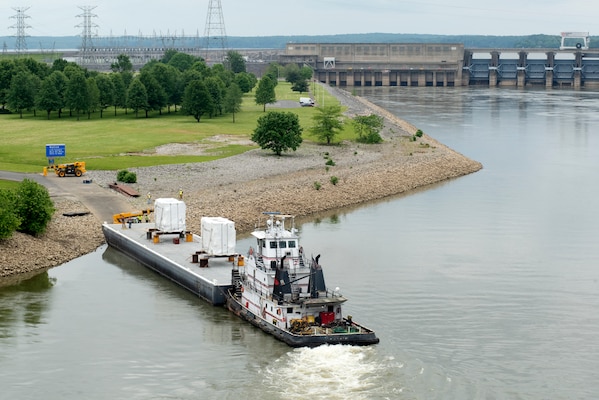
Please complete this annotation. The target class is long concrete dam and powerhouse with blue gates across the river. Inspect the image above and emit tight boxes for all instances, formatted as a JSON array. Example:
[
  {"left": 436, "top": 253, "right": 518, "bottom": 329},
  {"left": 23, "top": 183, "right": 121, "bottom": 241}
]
[{"left": 279, "top": 43, "right": 599, "bottom": 88}]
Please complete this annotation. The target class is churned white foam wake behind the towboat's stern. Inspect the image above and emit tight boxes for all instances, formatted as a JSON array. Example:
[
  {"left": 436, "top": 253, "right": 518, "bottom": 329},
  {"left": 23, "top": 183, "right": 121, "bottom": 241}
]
[{"left": 264, "top": 345, "right": 383, "bottom": 399}]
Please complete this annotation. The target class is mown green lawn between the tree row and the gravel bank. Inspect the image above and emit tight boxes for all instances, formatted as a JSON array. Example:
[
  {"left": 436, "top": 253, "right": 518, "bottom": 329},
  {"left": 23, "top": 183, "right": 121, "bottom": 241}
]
[{"left": 0, "top": 82, "right": 355, "bottom": 172}]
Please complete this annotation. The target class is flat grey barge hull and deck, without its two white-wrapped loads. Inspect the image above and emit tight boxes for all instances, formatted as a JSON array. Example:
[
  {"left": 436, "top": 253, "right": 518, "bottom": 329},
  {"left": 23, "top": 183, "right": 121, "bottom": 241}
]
[{"left": 102, "top": 223, "right": 237, "bottom": 305}]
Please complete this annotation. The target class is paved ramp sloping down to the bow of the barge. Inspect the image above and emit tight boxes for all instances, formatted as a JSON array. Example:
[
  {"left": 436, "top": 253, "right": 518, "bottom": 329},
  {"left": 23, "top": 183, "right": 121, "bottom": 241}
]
[{"left": 0, "top": 170, "right": 135, "bottom": 222}]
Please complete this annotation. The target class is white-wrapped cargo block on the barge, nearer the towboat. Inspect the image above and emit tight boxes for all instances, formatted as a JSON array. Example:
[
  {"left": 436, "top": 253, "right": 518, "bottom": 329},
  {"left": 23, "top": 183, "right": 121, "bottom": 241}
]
[{"left": 201, "top": 217, "right": 237, "bottom": 256}]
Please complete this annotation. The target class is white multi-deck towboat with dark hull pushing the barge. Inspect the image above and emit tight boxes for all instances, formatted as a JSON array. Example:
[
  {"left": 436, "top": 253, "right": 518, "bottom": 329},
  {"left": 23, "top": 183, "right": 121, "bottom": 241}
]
[{"left": 227, "top": 213, "right": 379, "bottom": 347}]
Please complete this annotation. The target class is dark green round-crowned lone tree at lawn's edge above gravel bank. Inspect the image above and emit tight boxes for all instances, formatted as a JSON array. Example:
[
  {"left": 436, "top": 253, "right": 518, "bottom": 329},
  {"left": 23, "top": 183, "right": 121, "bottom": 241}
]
[{"left": 251, "top": 111, "right": 302, "bottom": 156}]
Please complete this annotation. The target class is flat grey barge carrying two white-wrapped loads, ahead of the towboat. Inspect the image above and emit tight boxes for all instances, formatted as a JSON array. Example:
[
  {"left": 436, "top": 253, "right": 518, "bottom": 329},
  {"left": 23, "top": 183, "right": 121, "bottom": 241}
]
[{"left": 102, "top": 199, "right": 238, "bottom": 306}]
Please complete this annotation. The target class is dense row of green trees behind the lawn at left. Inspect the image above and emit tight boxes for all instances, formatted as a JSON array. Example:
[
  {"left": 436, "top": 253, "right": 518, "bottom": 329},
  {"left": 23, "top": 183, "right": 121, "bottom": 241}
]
[{"left": 0, "top": 50, "right": 257, "bottom": 122}]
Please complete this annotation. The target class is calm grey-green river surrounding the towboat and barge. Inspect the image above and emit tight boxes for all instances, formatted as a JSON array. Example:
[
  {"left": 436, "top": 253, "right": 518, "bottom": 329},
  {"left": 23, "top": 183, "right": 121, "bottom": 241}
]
[{"left": 0, "top": 87, "right": 599, "bottom": 400}]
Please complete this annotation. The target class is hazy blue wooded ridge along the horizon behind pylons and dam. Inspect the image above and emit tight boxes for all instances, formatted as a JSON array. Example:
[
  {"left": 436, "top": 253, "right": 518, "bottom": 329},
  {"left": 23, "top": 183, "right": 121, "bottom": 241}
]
[{"left": 0, "top": 33, "right": 599, "bottom": 51}]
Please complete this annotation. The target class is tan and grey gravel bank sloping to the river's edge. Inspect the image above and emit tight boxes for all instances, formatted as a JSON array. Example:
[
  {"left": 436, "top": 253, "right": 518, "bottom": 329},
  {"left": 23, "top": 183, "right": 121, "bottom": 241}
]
[{"left": 0, "top": 86, "right": 482, "bottom": 285}]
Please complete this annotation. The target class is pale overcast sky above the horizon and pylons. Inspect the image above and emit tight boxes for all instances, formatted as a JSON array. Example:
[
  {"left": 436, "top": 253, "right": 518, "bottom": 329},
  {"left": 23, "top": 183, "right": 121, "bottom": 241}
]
[{"left": 0, "top": 0, "right": 599, "bottom": 36}]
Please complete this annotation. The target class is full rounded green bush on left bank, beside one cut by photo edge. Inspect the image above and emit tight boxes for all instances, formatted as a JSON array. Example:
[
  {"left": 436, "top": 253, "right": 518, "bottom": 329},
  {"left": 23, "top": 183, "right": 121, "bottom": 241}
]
[{"left": 15, "top": 179, "right": 55, "bottom": 236}]
